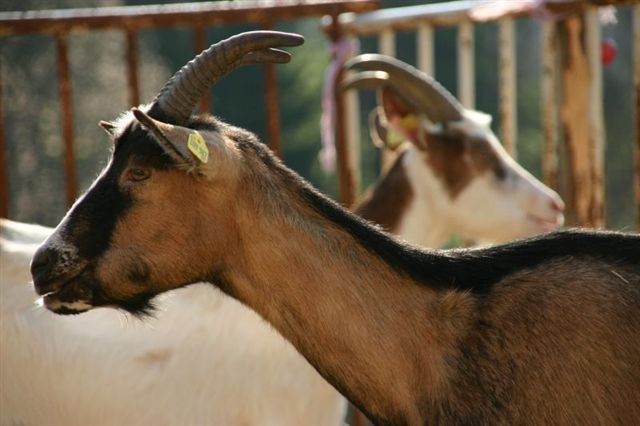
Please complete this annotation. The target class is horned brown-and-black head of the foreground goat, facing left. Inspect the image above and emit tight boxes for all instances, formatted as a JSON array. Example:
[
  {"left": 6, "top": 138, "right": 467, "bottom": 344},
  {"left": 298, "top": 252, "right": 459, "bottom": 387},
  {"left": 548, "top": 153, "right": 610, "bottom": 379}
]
[{"left": 31, "top": 31, "right": 304, "bottom": 314}]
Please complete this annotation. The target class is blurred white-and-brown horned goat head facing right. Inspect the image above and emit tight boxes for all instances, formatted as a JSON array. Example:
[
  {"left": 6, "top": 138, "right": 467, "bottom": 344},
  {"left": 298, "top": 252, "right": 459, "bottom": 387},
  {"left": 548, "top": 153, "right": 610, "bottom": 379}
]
[{"left": 343, "top": 54, "right": 564, "bottom": 243}]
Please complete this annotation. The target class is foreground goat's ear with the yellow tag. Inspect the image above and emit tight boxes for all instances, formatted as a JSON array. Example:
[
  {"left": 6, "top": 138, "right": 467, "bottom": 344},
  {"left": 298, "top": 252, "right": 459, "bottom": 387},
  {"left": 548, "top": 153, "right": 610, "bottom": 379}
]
[{"left": 132, "top": 108, "right": 204, "bottom": 169}]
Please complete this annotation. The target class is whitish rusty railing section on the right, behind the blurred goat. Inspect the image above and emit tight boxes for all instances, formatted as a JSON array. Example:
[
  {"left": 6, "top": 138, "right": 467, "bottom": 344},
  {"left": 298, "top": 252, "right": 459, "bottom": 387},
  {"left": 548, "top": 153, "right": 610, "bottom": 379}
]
[{"left": 334, "top": 0, "right": 640, "bottom": 230}]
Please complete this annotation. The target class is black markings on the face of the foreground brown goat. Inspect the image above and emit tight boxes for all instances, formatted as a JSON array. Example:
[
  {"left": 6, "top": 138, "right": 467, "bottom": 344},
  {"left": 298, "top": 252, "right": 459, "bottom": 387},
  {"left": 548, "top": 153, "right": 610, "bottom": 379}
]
[{"left": 48, "top": 116, "right": 219, "bottom": 310}]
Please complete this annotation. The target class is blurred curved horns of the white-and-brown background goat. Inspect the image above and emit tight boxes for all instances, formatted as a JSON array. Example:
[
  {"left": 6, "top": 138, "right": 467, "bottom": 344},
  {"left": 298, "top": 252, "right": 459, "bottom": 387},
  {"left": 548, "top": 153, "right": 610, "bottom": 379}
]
[{"left": 345, "top": 53, "right": 464, "bottom": 123}]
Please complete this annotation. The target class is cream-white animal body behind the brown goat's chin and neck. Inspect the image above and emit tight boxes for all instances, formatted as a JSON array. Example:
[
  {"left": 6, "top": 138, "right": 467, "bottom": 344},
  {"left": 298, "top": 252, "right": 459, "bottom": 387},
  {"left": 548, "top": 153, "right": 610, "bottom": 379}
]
[{"left": 0, "top": 219, "right": 346, "bottom": 426}]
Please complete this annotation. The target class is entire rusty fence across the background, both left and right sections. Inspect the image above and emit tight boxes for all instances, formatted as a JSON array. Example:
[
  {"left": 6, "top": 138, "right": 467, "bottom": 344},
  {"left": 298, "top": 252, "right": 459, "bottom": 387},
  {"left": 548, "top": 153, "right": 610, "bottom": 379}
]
[{"left": 0, "top": 0, "right": 640, "bottom": 422}]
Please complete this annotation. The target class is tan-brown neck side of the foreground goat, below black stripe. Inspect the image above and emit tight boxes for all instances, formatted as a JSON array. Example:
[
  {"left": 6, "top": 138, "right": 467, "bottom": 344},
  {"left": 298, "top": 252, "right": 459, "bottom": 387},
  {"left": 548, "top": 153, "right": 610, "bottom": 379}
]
[{"left": 218, "top": 176, "right": 472, "bottom": 423}]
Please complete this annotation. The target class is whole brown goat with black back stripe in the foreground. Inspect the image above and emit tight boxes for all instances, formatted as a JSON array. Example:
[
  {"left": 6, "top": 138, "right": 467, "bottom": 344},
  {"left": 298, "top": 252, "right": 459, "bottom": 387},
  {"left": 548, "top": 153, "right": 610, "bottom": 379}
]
[{"left": 32, "top": 32, "right": 640, "bottom": 425}]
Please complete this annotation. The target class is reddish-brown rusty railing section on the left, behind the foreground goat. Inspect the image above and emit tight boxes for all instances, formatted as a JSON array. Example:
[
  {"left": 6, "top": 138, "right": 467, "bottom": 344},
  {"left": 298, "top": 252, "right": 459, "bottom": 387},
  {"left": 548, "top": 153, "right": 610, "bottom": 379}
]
[{"left": 0, "top": 0, "right": 380, "bottom": 217}]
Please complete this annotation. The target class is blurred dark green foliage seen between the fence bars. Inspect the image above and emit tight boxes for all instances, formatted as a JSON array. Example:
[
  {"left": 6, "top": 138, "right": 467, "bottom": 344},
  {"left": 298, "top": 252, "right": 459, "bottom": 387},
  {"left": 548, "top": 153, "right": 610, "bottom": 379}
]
[{"left": 0, "top": 0, "right": 635, "bottom": 229}]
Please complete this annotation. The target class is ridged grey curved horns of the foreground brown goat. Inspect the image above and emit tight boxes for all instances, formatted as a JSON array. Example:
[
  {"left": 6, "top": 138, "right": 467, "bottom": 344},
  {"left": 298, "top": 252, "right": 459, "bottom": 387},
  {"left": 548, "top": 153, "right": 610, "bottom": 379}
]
[{"left": 154, "top": 31, "right": 304, "bottom": 124}]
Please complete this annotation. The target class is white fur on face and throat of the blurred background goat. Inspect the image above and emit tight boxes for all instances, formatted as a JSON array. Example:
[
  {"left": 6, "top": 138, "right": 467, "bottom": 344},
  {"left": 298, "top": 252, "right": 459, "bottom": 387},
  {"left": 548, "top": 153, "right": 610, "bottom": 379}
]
[{"left": 397, "top": 110, "right": 564, "bottom": 247}]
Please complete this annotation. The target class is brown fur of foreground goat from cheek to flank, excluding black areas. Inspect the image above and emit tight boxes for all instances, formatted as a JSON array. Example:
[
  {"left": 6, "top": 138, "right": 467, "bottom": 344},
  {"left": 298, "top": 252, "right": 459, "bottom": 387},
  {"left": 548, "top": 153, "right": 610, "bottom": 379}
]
[{"left": 89, "top": 127, "right": 640, "bottom": 424}]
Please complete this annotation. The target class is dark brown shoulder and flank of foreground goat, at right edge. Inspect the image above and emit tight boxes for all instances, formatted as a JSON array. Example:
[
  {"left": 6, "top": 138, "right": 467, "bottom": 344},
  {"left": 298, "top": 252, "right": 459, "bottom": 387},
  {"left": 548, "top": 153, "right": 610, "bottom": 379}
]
[{"left": 453, "top": 258, "right": 640, "bottom": 425}]
